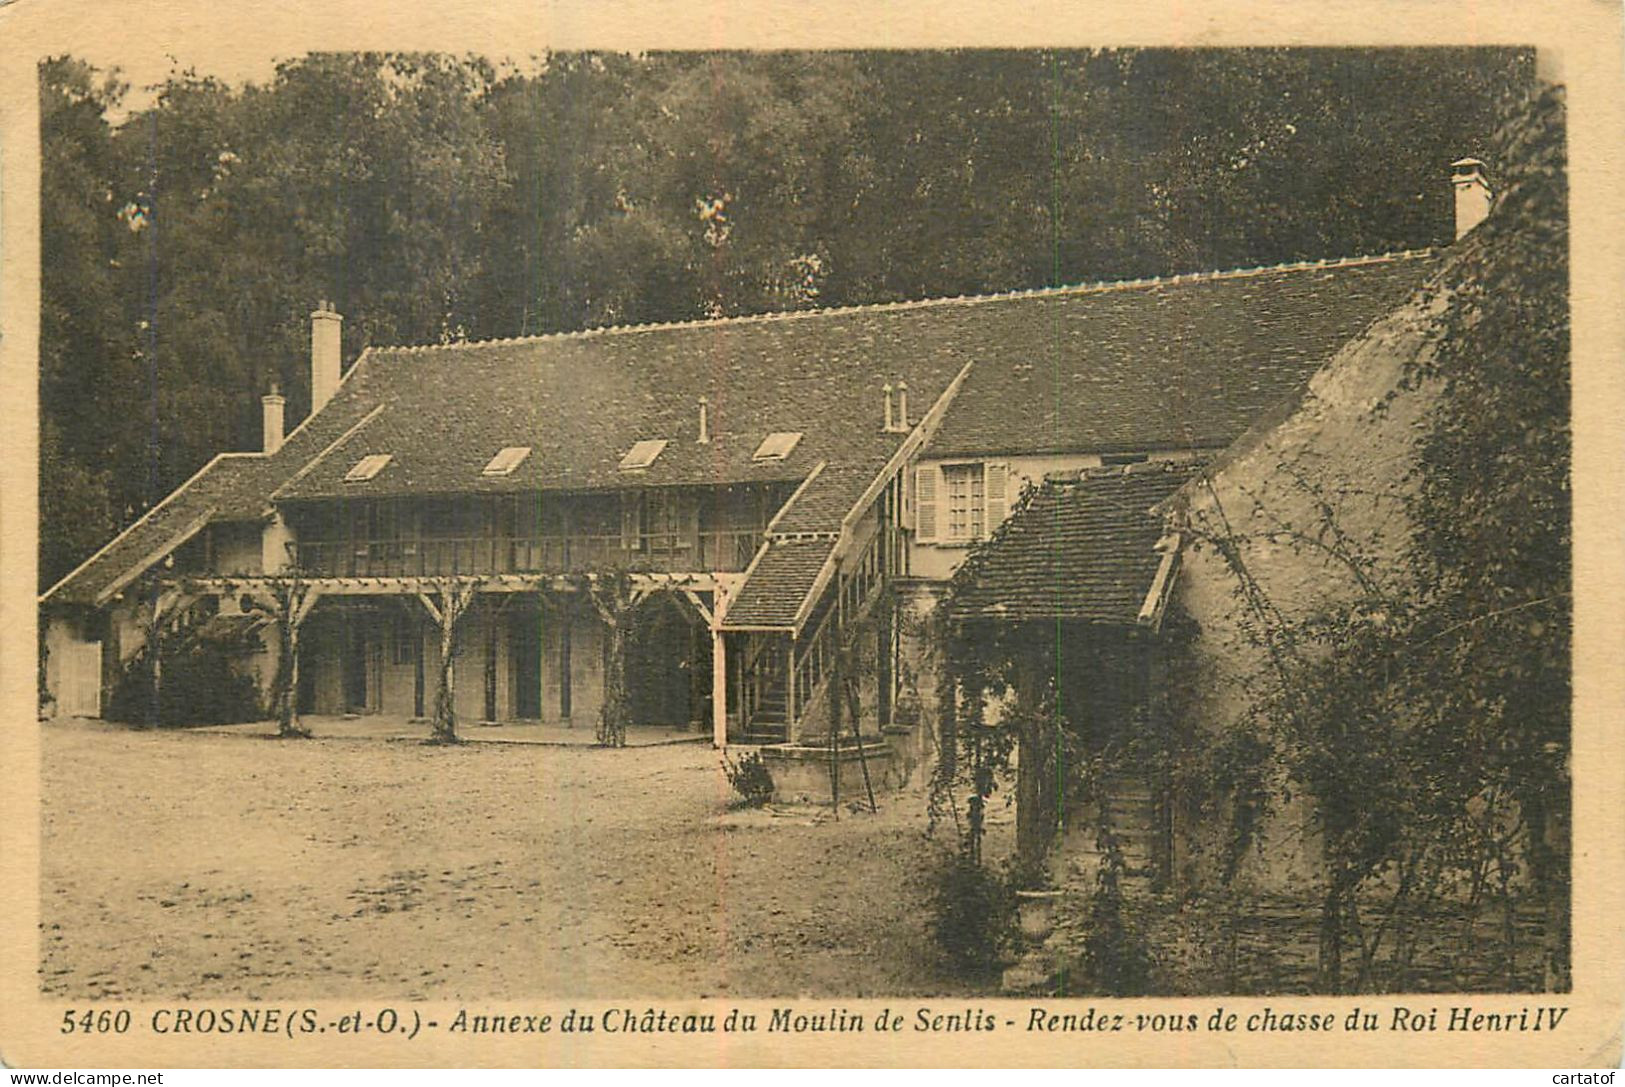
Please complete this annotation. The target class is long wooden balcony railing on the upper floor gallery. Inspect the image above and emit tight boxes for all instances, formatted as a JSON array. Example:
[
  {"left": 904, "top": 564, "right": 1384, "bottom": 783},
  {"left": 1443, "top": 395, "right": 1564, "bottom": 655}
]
[{"left": 294, "top": 531, "right": 761, "bottom": 577}]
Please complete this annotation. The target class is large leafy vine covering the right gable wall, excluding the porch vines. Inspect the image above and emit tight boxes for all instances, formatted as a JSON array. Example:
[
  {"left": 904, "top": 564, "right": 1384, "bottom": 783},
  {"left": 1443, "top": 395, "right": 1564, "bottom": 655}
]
[{"left": 1183, "top": 93, "right": 1570, "bottom": 993}]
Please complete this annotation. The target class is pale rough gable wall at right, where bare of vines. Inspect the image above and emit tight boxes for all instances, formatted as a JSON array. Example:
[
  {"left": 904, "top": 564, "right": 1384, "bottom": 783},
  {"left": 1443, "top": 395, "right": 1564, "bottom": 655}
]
[{"left": 1168, "top": 282, "right": 1446, "bottom": 890}]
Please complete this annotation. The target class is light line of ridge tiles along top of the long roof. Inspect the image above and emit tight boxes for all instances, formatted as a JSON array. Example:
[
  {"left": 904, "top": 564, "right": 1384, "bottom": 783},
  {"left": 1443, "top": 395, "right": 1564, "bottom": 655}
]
[{"left": 371, "top": 247, "right": 1438, "bottom": 354}]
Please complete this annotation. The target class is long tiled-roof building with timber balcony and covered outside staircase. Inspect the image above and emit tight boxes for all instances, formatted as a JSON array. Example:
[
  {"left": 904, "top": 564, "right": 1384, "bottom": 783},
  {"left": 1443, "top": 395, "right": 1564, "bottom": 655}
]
[{"left": 42, "top": 242, "right": 1437, "bottom": 743}]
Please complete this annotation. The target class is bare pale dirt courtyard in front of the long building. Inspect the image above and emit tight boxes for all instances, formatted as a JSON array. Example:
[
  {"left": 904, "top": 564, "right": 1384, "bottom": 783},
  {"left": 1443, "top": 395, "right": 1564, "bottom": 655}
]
[{"left": 41, "top": 723, "right": 964, "bottom": 999}]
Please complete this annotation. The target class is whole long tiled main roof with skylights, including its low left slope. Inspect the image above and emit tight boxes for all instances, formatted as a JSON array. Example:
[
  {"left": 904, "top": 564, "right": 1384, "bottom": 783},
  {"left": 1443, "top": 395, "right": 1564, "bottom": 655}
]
[{"left": 46, "top": 253, "right": 1437, "bottom": 614}]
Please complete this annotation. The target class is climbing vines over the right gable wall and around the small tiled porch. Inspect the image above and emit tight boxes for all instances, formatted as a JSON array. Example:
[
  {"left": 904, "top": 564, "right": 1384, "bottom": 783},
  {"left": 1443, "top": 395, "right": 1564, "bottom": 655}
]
[{"left": 931, "top": 89, "right": 1571, "bottom": 993}]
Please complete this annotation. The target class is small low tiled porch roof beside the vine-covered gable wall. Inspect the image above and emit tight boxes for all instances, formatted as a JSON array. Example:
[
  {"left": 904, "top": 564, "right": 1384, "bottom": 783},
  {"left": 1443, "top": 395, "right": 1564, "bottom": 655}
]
[{"left": 952, "top": 463, "right": 1198, "bottom": 626}]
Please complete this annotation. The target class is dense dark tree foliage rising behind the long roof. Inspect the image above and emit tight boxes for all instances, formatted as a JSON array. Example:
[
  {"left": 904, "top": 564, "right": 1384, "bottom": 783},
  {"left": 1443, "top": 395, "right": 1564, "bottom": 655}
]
[{"left": 41, "top": 50, "right": 1532, "bottom": 583}]
